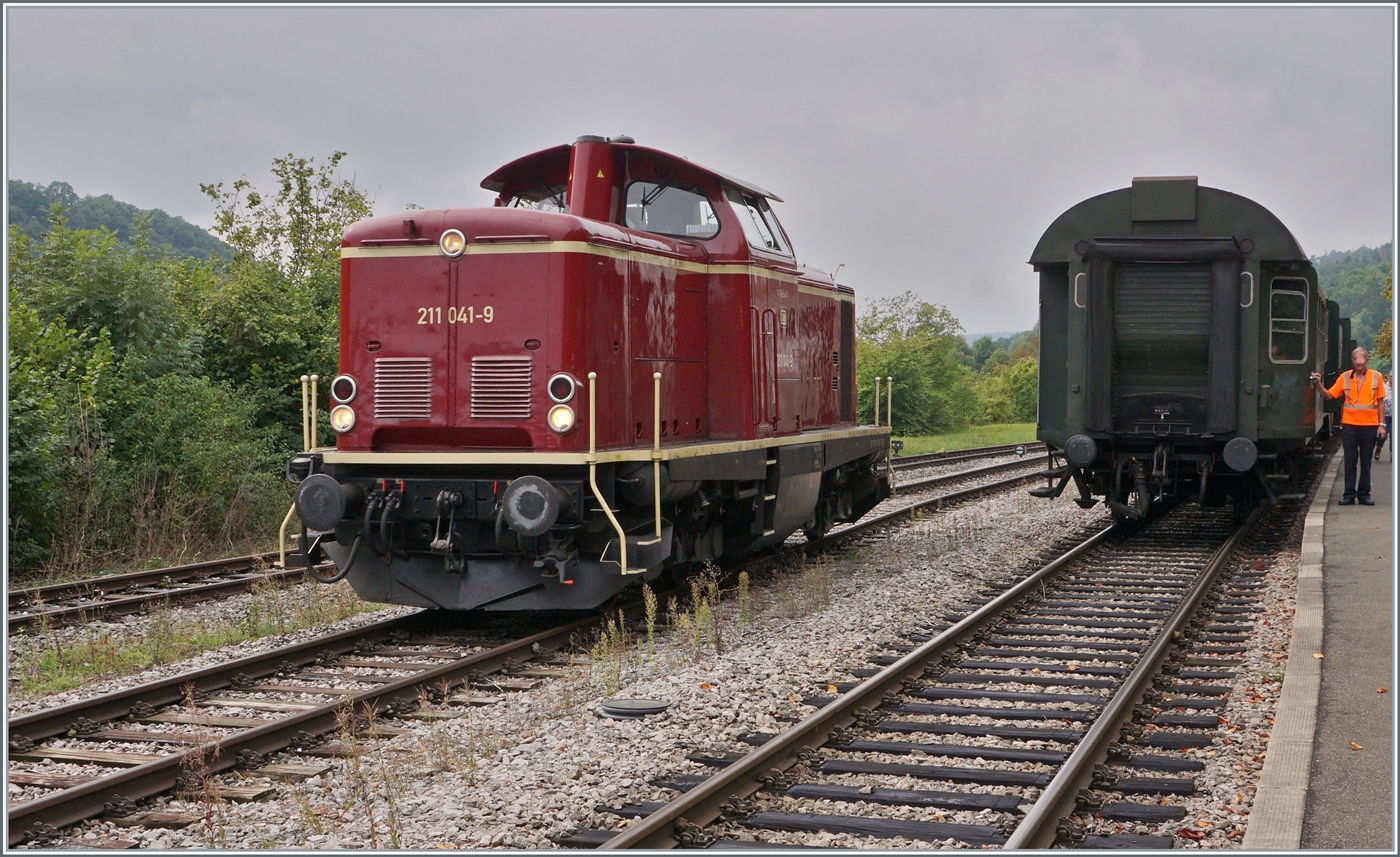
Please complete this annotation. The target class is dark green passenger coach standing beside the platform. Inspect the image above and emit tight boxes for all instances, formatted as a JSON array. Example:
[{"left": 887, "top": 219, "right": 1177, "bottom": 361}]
[{"left": 1030, "top": 176, "right": 1355, "bottom": 520}]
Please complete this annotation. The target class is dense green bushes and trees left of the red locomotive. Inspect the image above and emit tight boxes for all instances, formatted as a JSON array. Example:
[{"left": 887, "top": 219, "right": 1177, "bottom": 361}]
[{"left": 7, "top": 153, "right": 372, "bottom": 576}]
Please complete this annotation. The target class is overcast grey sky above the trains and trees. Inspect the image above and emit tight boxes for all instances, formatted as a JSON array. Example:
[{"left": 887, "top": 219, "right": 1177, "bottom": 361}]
[{"left": 6, "top": 6, "right": 1396, "bottom": 332}]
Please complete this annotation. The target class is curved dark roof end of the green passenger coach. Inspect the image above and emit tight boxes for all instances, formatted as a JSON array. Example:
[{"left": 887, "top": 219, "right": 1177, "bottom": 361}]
[{"left": 1030, "top": 176, "right": 1308, "bottom": 265}]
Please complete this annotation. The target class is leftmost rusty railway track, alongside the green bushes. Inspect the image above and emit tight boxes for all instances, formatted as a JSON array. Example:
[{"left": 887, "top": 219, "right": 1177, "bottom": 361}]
[{"left": 6, "top": 552, "right": 302, "bottom": 634}]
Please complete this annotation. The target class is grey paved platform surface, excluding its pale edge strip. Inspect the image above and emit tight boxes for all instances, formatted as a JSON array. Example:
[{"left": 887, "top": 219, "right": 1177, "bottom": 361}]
[{"left": 1289, "top": 448, "right": 1400, "bottom": 851}]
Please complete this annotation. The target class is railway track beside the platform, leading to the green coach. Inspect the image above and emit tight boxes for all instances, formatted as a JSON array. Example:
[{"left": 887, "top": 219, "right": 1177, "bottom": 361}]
[{"left": 559, "top": 481, "right": 1295, "bottom": 849}]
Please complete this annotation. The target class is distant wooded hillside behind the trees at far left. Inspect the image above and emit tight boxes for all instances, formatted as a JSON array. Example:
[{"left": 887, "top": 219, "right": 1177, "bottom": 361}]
[{"left": 10, "top": 179, "right": 230, "bottom": 259}]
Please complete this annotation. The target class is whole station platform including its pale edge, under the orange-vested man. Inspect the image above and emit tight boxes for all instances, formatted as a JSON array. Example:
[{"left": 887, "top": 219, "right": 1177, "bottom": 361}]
[{"left": 1243, "top": 445, "right": 1400, "bottom": 853}]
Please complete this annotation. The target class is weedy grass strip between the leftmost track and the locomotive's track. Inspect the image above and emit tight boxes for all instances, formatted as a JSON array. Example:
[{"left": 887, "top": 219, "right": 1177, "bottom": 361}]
[{"left": 10, "top": 581, "right": 381, "bottom": 693}]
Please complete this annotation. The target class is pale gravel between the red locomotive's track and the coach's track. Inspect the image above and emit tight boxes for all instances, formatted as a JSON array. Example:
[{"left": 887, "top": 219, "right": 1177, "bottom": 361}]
[{"left": 13, "top": 478, "right": 1106, "bottom": 849}]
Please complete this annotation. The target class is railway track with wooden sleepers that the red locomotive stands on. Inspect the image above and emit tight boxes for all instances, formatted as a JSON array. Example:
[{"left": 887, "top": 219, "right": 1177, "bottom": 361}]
[{"left": 7, "top": 445, "right": 1033, "bottom": 846}]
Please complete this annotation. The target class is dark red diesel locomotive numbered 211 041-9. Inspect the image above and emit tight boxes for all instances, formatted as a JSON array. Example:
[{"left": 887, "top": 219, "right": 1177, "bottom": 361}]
[{"left": 288, "top": 137, "right": 889, "bottom": 611}]
